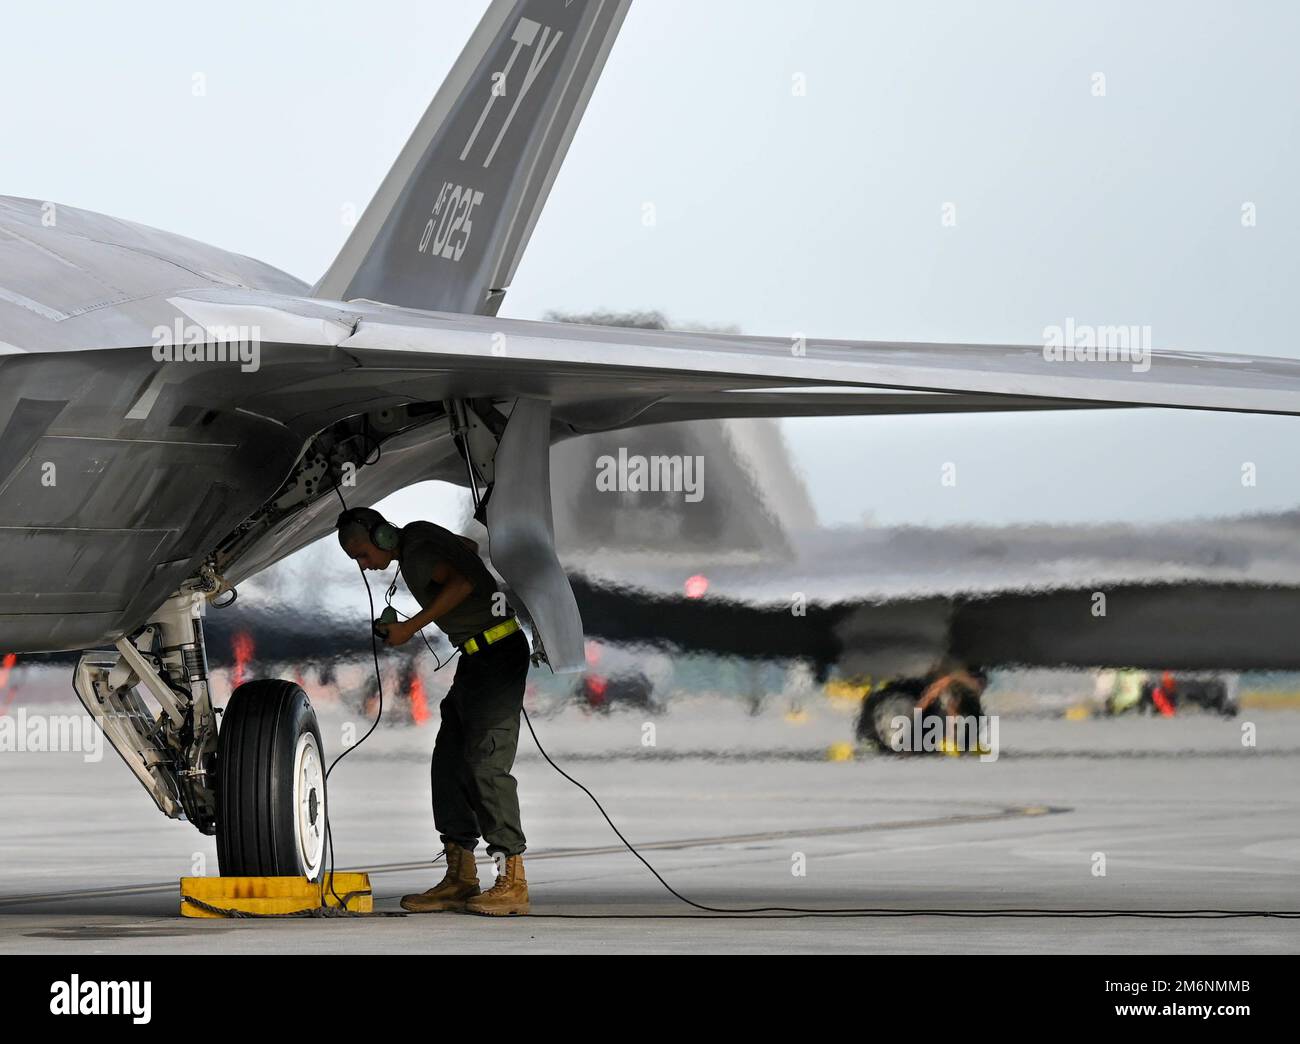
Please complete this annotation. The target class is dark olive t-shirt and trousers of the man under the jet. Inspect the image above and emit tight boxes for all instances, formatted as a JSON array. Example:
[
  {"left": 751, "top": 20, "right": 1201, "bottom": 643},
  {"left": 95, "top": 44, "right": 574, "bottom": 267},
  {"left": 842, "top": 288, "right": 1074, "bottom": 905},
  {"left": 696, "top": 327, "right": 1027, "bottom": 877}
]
[{"left": 398, "top": 521, "right": 529, "bottom": 857}]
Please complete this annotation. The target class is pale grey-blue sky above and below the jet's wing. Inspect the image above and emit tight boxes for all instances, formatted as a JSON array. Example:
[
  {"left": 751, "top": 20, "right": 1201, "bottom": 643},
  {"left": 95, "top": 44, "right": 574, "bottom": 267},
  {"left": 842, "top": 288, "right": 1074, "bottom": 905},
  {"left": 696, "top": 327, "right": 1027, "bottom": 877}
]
[{"left": 0, "top": 0, "right": 1300, "bottom": 523}]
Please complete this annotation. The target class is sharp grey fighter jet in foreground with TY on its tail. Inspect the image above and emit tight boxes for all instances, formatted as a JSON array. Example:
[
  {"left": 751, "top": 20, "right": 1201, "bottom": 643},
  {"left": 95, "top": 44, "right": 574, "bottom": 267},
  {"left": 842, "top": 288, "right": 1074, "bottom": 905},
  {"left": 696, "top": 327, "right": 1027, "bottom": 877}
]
[{"left": 0, "top": 0, "right": 1300, "bottom": 878}]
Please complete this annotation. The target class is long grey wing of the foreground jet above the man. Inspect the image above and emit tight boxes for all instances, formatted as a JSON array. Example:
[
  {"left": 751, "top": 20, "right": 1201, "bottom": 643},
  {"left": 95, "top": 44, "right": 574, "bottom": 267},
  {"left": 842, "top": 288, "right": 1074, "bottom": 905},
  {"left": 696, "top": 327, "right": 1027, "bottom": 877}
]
[{"left": 157, "top": 289, "right": 1300, "bottom": 433}]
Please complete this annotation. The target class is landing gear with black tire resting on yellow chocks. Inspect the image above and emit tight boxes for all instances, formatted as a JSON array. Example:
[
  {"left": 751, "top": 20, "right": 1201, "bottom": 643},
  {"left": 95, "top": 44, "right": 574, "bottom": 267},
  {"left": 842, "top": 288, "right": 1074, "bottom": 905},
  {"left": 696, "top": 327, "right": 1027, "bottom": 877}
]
[{"left": 73, "top": 575, "right": 326, "bottom": 880}]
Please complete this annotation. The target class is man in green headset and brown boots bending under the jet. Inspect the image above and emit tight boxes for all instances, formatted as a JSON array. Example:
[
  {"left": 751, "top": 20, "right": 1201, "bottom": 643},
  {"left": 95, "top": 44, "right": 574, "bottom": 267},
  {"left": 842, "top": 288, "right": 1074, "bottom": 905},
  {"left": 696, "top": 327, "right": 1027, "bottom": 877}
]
[{"left": 337, "top": 507, "right": 529, "bottom": 914}]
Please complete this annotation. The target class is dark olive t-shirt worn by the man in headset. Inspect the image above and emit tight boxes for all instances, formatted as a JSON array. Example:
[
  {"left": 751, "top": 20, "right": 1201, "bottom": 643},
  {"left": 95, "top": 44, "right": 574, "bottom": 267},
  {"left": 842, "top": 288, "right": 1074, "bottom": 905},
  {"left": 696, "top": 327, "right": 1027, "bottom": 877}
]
[{"left": 398, "top": 521, "right": 514, "bottom": 645}]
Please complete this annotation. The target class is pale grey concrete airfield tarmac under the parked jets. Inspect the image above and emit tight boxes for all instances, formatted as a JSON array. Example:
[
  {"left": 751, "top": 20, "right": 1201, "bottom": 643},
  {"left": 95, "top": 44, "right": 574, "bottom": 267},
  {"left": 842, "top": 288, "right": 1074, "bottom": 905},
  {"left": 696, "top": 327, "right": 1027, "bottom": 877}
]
[{"left": 0, "top": 701, "right": 1300, "bottom": 954}]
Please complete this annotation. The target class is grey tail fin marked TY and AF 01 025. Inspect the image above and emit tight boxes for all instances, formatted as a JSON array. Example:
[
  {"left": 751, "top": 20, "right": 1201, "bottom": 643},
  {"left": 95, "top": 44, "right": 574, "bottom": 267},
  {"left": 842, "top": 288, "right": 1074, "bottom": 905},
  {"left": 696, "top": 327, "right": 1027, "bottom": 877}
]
[{"left": 312, "top": 0, "right": 631, "bottom": 315}]
